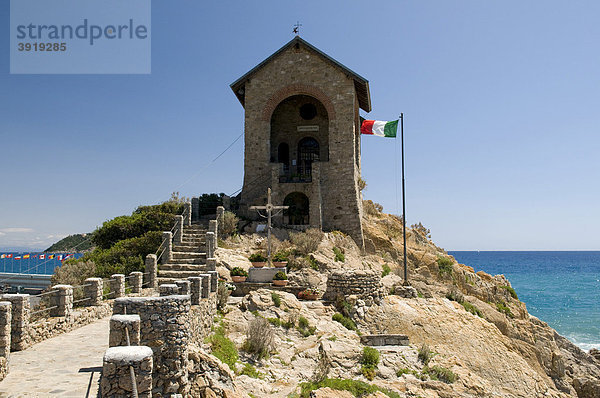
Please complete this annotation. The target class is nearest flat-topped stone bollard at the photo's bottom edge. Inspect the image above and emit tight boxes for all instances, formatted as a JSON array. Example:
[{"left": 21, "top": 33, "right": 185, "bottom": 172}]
[{"left": 100, "top": 346, "right": 153, "bottom": 398}]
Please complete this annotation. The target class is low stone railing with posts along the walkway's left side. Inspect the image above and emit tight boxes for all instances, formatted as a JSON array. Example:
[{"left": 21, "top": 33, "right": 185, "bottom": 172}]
[{"left": 0, "top": 272, "right": 156, "bottom": 379}]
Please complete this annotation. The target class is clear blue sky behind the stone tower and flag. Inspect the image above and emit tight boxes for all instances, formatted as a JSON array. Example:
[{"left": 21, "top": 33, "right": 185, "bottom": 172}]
[{"left": 0, "top": 0, "right": 600, "bottom": 250}]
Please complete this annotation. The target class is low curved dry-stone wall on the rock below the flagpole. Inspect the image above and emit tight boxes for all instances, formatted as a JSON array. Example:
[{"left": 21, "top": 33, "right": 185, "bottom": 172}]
[{"left": 323, "top": 270, "right": 383, "bottom": 303}]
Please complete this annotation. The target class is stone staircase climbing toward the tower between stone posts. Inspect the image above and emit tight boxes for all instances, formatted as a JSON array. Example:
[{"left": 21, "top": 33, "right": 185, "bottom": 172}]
[{"left": 158, "top": 224, "right": 207, "bottom": 285}]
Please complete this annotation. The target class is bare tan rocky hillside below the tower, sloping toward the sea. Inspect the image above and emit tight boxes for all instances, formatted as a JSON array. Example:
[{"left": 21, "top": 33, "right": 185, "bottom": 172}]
[{"left": 205, "top": 204, "right": 600, "bottom": 398}]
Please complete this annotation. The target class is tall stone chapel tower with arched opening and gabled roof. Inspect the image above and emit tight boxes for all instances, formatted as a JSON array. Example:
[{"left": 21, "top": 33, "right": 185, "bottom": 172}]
[{"left": 231, "top": 36, "right": 371, "bottom": 247}]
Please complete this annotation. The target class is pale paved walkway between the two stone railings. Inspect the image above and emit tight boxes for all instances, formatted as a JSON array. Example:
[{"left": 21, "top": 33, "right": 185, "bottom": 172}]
[{"left": 0, "top": 317, "right": 110, "bottom": 398}]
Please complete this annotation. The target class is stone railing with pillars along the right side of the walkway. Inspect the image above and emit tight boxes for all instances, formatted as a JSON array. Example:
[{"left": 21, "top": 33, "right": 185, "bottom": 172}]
[{"left": 105, "top": 271, "right": 218, "bottom": 397}]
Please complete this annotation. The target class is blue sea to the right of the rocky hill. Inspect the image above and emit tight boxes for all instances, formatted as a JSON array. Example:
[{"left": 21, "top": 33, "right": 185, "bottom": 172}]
[{"left": 448, "top": 251, "right": 600, "bottom": 351}]
